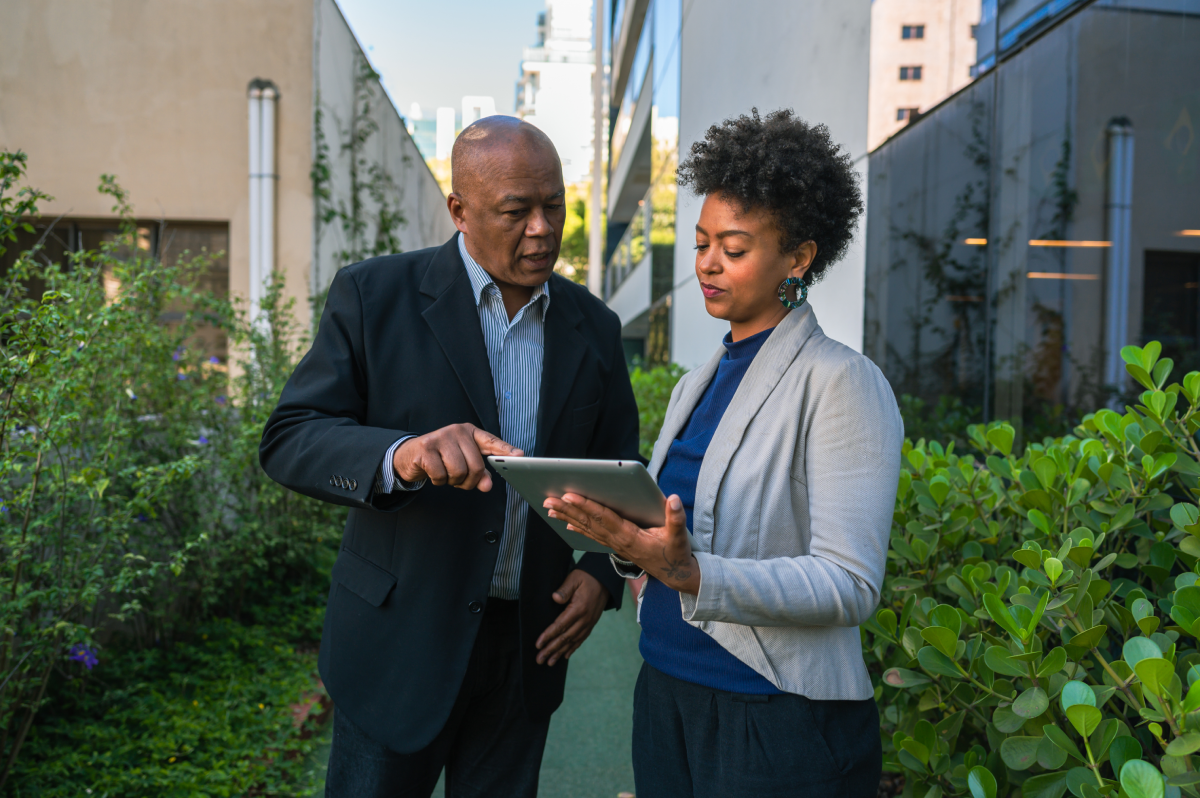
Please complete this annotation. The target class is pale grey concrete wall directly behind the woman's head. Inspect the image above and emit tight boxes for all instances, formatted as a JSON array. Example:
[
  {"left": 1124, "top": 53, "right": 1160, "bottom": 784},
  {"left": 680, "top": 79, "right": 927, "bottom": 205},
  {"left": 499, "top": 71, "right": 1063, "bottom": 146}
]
[{"left": 671, "top": 0, "right": 871, "bottom": 367}]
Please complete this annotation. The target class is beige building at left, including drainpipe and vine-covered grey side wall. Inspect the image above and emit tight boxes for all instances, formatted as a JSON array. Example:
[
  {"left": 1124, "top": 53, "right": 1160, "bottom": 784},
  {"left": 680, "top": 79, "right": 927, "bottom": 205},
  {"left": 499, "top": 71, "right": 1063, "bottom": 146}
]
[{"left": 0, "top": 0, "right": 454, "bottom": 338}]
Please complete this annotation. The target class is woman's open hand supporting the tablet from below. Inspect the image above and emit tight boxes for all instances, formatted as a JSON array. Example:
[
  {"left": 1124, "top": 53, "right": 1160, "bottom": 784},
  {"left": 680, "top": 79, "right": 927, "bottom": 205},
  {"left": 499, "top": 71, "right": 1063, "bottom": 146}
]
[{"left": 542, "top": 493, "right": 700, "bottom": 595}]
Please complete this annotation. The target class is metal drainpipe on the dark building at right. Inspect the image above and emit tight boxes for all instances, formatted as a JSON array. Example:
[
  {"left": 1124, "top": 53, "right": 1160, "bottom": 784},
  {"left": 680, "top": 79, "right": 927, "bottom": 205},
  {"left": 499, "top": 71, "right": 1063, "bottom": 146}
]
[{"left": 1104, "top": 116, "right": 1134, "bottom": 396}]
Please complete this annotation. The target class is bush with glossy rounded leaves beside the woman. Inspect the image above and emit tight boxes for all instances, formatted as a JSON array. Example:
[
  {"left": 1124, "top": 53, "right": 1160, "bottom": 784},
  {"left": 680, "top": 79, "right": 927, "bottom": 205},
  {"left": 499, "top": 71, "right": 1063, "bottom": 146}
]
[{"left": 863, "top": 342, "right": 1200, "bottom": 798}]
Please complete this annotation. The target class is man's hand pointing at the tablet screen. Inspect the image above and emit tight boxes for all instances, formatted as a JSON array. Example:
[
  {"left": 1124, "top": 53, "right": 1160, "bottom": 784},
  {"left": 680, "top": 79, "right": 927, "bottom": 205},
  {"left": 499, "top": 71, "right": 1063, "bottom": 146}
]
[{"left": 391, "top": 424, "right": 524, "bottom": 493}]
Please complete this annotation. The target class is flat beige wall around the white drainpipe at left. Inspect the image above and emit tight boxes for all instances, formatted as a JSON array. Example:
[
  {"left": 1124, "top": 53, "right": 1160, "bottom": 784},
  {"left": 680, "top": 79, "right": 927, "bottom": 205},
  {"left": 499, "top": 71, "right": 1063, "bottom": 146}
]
[{"left": 0, "top": 0, "right": 313, "bottom": 326}]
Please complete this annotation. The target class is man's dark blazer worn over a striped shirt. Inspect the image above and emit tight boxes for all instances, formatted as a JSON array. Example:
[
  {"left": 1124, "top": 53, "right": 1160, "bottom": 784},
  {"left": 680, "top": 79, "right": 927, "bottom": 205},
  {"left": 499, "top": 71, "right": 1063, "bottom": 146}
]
[{"left": 259, "top": 236, "right": 637, "bottom": 752}]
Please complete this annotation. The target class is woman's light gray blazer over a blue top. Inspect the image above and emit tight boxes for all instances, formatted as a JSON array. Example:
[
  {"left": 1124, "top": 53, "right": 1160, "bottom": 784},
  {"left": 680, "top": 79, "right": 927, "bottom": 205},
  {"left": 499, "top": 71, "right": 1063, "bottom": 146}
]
[{"left": 649, "top": 305, "right": 904, "bottom": 700}]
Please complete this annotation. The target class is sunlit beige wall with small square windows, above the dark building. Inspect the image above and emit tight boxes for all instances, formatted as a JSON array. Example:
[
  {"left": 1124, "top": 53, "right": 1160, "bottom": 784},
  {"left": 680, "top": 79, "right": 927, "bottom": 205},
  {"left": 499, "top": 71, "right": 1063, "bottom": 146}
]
[{"left": 868, "top": 0, "right": 980, "bottom": 150}]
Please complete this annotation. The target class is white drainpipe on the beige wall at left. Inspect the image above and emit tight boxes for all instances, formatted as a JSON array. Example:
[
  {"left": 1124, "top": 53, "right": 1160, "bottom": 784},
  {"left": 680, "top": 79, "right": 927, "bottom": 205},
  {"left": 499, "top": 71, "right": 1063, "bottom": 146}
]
[{"left": 247, "top": 78, "right": 280, "bottom": 319}]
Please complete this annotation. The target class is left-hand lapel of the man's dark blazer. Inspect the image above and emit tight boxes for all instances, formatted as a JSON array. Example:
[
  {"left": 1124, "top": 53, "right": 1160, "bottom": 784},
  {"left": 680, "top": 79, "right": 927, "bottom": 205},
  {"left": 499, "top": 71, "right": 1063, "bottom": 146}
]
[{"left": 421, "top": 234, "right": 500, "bottom": 436}]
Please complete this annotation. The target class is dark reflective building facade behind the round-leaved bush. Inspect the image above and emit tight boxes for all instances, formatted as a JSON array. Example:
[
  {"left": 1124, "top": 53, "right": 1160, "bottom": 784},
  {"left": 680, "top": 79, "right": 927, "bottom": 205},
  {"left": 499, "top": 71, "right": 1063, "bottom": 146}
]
[{"left": 865, "top": 0, "right": 1200, "bottom": 430}]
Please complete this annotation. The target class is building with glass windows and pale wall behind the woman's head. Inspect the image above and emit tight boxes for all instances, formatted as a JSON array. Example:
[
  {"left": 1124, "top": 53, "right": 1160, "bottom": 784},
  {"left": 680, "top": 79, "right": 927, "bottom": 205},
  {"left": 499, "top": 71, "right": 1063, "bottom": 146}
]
[{"left": 602, "top": 0, "right": 870, "bottom": 367}]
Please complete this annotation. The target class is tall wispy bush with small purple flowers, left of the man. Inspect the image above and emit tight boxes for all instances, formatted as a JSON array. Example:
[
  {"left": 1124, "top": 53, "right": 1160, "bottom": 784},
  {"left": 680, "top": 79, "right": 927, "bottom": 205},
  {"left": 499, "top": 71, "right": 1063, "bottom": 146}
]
[{"left": 0, "top": 147, "right": 340, "bottom": 791}]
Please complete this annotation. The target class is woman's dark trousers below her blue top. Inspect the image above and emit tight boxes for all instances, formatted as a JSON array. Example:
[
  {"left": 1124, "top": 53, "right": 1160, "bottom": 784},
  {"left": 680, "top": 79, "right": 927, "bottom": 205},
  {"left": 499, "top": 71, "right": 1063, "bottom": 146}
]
[{"left": 634, "top": 664, "right": 883, "bottom": 798}]
